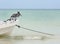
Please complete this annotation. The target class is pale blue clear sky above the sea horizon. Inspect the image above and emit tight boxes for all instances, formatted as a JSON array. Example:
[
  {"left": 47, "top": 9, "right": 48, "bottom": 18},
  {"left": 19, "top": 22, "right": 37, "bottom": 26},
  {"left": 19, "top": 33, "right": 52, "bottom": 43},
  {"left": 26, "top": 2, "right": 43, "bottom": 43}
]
[{"left": 0, "top": 0, "right": 60, "bottom": 9}]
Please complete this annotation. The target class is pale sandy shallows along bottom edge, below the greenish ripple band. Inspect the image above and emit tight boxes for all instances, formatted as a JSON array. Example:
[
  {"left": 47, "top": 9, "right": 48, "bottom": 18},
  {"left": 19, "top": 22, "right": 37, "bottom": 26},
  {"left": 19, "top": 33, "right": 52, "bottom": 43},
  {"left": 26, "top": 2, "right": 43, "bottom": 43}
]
[{"left": 0, "top": 39, "right": 60, "bottom": 44}]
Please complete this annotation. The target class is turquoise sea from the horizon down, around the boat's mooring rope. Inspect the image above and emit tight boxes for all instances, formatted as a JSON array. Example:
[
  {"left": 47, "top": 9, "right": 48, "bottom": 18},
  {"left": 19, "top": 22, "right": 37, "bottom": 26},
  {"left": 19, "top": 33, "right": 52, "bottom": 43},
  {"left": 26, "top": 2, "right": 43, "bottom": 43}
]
[{"left": 0, "top": 9, "right": 60, "bottom": 35}]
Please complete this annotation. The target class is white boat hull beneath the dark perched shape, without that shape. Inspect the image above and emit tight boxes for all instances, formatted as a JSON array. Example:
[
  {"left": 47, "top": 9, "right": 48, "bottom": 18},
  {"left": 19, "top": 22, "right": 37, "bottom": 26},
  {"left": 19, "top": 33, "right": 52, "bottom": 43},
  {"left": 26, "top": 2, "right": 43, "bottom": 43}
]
[{"left": 0, "top": 21, "right": 17, "bottom": 35}]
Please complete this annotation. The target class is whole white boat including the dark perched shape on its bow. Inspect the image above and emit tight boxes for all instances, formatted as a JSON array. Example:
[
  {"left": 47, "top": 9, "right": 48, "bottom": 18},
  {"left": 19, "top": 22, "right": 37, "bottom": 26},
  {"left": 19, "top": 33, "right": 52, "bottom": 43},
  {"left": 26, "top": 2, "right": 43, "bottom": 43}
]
[{"left": 0, "top": 12, "right": 21, "bottom": 35}]
